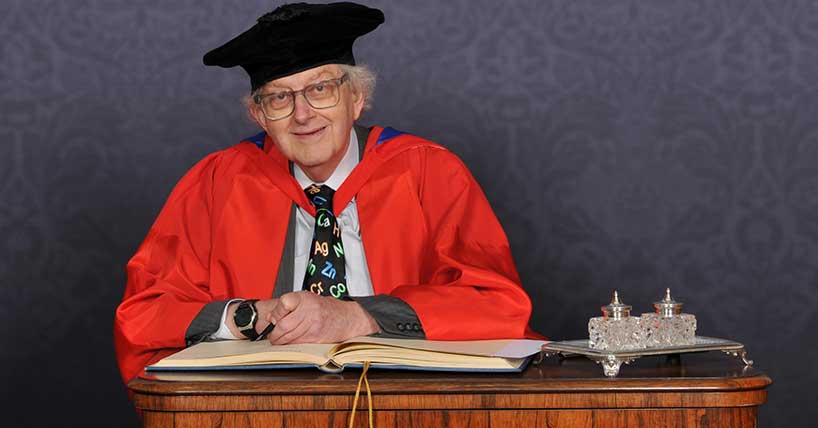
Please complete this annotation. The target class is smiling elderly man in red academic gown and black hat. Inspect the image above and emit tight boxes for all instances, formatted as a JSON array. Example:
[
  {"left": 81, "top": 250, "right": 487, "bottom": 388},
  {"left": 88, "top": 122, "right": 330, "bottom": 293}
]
[{"left": 114, "top": 3, "right": 533, "bottom": 382}]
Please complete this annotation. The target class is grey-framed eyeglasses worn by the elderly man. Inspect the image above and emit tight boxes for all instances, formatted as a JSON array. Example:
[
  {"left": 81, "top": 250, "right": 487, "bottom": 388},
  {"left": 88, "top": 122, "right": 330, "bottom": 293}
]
[{"left": 253, "top": 73, "right": 349, "bottom": 120}]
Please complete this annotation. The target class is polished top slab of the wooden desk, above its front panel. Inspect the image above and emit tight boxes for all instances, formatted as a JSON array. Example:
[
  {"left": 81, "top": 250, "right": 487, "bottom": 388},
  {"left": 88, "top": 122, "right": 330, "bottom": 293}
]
[{"left": 129, "top": 352, "right": 772, "bottom": 395}]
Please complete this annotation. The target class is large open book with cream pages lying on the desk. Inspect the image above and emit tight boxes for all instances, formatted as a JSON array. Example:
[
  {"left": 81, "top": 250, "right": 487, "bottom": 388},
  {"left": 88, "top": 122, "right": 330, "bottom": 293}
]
[{"left": 146, "top": 337, "right": 546, "bottom": 373}]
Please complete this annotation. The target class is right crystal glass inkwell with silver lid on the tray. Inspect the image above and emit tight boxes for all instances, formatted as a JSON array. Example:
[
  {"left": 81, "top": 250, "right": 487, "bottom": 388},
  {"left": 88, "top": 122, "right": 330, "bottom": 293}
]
[{"left": 640, "top": 288, "right": 696, "bottom": 347}]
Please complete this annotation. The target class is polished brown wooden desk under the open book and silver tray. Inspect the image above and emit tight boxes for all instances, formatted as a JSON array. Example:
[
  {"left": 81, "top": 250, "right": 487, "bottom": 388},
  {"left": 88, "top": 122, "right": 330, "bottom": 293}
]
[{"left": 128, "top": 352, "right": 771, "bottom": 428}]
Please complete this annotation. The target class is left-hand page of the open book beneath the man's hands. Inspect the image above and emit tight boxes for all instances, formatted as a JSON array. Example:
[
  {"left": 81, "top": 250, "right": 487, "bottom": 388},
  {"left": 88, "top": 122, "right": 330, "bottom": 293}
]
[{"left": 149, "top": 340, "right": 335, "bottom": 368}]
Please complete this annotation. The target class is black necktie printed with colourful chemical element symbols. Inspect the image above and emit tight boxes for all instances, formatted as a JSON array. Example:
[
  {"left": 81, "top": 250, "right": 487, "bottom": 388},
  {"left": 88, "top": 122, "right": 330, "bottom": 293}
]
[{"left": 301, "top": 184, "right": 349, "bottom": 300}]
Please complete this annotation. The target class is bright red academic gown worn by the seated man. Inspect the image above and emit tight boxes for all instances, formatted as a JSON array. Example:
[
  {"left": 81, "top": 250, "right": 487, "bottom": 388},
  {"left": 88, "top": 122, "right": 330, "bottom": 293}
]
[{"left": 114, "top": 127, "right": 539, "bottom": 382}]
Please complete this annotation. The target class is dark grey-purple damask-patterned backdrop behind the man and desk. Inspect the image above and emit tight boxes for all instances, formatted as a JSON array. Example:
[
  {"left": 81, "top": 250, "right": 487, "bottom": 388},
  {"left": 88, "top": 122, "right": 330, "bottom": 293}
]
[{"left": 0, "top": 0, "right": 818, "bottom": 427}]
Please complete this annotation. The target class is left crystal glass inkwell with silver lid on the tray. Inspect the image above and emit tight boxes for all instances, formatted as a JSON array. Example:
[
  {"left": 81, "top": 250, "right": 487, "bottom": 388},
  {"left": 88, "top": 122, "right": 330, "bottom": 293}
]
[{"left": 588, "top": 290, "right": 646, "bottom": 351}]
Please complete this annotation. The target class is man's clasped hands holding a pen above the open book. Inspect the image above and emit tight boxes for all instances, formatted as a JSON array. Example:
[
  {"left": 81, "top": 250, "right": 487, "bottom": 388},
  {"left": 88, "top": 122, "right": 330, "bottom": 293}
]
[{"left": 259, "top": 291, "right": 380, "bottom": 345}]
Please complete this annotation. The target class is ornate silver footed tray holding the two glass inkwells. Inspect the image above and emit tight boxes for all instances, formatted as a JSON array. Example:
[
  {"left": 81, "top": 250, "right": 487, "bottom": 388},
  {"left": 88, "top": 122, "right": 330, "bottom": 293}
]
[{"left": 540, "top": 336, "right": 753, "bottom": 377}]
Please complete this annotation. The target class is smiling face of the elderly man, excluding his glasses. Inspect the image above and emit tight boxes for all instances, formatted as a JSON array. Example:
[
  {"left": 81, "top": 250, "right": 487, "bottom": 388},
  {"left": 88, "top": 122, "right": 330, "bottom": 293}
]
[{"left": 250, "top": 64, "right": 364, "bottom": 182}]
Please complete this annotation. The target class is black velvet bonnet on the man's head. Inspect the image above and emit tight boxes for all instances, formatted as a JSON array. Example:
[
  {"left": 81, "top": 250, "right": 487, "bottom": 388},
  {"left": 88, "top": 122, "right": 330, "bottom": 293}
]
[{"left": 202, "top": 2, "right": 384, "bottom": 90}]
